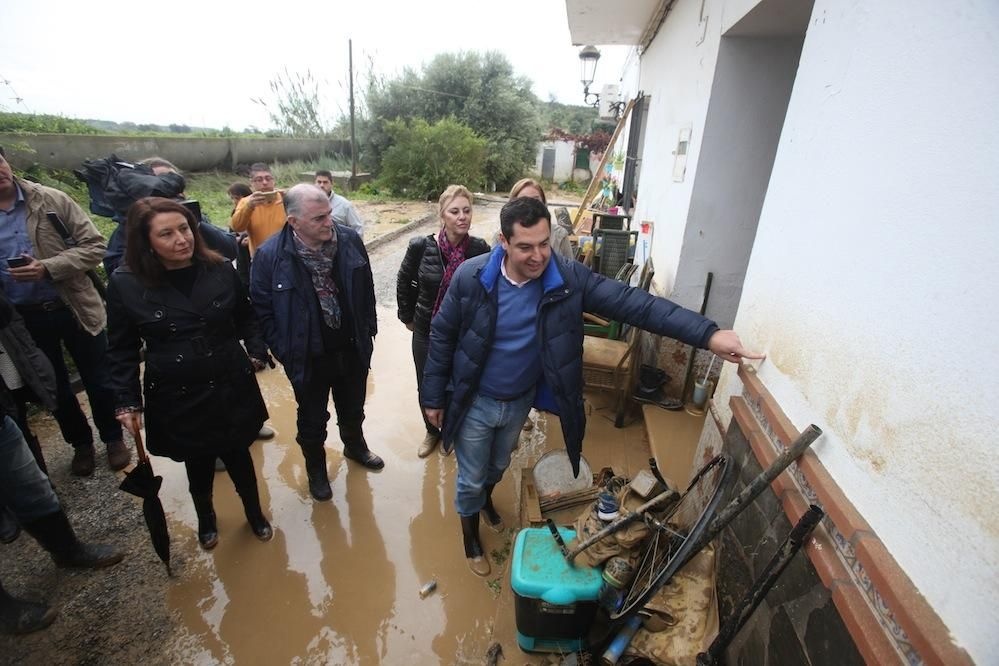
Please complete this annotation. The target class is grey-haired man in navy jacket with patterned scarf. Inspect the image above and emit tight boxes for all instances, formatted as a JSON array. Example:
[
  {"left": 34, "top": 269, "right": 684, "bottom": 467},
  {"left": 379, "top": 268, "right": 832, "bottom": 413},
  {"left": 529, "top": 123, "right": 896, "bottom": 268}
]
[{"left": 250, "top": 184, "right": 385, "bottom": 501}]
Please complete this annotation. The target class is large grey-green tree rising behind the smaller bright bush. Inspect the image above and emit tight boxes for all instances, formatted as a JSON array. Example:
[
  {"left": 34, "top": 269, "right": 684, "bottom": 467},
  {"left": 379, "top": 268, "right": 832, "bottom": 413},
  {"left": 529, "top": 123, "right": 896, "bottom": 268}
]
[{"left": 363, "top": 52, "right": 542, "bottom": 187}]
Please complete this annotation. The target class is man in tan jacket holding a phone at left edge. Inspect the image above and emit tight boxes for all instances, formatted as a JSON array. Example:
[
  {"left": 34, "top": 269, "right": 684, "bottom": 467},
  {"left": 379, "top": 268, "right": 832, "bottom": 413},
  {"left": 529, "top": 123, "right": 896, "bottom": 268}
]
[{"left": 0, "top": 148, "right": 129, "bottom": 476}]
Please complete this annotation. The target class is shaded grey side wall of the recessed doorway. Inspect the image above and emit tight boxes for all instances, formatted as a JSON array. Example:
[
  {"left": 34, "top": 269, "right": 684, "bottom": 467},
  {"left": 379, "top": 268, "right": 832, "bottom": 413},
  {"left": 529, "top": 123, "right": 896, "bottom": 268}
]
[{"left": 670, "top": 37, "right": 802, "bottom": 328}]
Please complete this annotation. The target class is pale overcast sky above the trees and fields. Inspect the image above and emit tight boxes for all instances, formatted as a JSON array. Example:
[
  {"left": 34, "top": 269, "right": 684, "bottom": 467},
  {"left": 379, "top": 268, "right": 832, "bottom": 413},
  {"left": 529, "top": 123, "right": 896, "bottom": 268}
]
[{"left": 0, "top": 0, "right": 627, "bottom": 130}]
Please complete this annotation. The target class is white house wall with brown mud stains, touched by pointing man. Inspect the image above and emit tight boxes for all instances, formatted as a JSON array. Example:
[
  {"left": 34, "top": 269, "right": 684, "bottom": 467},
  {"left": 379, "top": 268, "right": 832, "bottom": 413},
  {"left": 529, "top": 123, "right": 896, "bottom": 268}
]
[{"left": 716, "top": 0, "right": 999, "bottom": 664}]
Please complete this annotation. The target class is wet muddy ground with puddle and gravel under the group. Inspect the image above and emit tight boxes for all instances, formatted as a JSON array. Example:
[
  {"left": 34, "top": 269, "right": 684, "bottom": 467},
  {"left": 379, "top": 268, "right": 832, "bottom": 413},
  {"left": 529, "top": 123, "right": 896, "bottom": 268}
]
[{"left": 0, "top": 195, "right": 660, "bottom": 664}]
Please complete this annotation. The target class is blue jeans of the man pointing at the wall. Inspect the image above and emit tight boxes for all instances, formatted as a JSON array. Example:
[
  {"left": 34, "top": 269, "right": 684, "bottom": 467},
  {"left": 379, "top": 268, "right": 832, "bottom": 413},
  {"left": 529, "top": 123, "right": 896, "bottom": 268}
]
[{"left": 454, "top": 389, "right": 534, "bottom": 516}]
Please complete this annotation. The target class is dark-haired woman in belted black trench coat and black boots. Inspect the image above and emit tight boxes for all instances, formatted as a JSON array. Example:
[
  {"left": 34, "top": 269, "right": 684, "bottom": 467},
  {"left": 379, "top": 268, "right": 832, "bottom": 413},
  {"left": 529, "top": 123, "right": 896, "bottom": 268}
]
[{"left": 108, "top": 197, "right": 273, "bottom": 550}]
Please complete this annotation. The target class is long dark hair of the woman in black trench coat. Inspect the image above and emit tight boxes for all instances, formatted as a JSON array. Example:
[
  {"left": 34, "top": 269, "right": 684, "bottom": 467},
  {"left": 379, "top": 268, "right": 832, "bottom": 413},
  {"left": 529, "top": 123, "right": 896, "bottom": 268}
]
[{"left": 125, "top": 197, "right": 225, "bottom": 285}]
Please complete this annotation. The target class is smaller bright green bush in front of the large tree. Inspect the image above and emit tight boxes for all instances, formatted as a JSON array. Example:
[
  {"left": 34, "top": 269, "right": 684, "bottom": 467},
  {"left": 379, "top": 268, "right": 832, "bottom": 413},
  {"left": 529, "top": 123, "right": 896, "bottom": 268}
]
[{"left": 379, "top": 118, "right": 488, "bottom": 199}]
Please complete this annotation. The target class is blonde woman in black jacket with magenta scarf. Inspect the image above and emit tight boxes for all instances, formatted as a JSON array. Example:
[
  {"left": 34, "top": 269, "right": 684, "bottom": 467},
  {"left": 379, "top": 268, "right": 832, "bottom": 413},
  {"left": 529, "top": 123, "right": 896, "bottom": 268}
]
[{"left": 396, "top": 185, "right": 489, "bottom": 458}]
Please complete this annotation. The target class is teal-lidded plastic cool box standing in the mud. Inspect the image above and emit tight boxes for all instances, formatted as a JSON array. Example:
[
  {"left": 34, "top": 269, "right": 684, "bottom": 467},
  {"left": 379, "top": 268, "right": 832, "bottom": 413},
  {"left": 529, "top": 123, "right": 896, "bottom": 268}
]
[{"left": 510, "top": 527, "right": 603, "bottom": 652}]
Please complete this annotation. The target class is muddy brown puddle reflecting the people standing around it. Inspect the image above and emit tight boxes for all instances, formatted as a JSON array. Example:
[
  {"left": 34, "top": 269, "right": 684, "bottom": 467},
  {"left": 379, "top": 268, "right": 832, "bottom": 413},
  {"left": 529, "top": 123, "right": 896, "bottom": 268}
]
[{"left": 162, "top": 309, "right": 516, "bottom": 664}]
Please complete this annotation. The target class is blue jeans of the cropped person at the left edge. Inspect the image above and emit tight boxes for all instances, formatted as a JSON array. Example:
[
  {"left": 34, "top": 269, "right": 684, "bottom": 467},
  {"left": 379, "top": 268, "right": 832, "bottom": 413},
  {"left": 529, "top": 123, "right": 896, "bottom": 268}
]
[{"left": 0, "top": 416, "right": 59, "bottom": 525}]
